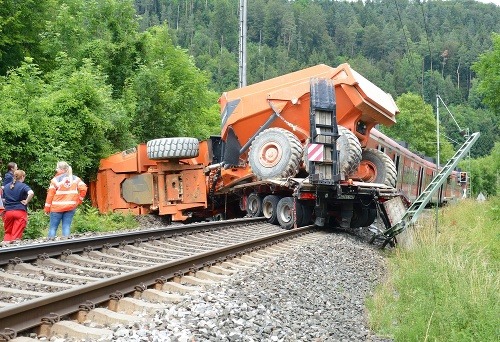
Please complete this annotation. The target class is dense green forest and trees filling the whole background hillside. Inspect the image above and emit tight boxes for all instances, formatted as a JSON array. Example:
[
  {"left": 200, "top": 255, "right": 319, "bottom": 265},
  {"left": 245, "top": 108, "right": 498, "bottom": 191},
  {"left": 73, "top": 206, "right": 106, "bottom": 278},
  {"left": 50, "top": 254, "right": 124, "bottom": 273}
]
[{"left": 0, "top": 0, "right": 500, "bottom": 200}]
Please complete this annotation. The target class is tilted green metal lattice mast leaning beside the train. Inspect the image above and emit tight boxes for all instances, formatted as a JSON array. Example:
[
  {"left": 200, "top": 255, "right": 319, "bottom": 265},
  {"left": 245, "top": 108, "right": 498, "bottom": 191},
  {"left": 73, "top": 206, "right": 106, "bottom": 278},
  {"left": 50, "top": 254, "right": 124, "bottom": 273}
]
[{"left": 378, "top": 132, "right": 480, "bottom": 246}]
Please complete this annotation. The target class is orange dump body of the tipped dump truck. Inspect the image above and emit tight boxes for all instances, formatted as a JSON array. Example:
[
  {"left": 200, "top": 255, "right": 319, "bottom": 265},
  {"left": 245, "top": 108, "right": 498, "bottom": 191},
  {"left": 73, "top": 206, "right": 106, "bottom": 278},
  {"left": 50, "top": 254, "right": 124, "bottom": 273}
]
[{"left": 219, "top": 64, "right": 399, "bottom": 151}]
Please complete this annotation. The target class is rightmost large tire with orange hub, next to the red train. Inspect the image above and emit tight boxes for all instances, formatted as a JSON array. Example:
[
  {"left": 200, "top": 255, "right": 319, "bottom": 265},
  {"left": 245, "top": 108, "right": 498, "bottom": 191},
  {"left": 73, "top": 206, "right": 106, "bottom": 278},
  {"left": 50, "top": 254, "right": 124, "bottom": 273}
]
[{"left": 361, "top": 148, "right": 397, "bottom": 187}]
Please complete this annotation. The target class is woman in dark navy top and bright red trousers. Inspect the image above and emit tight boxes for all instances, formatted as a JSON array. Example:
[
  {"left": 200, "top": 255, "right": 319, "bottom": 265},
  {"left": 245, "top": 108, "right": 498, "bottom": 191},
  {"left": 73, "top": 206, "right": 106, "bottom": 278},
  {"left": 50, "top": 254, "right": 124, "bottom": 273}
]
[{"left": 3, "top": 170, "right": 35, "bottom": 243}]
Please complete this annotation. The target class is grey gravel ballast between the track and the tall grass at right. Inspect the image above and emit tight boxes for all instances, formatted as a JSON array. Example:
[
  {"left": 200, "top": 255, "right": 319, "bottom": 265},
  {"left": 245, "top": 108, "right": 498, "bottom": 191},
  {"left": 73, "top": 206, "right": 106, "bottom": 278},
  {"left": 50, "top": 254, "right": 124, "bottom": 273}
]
[{"left": 103, "top": 233, "right": 390, "bottom": 342}]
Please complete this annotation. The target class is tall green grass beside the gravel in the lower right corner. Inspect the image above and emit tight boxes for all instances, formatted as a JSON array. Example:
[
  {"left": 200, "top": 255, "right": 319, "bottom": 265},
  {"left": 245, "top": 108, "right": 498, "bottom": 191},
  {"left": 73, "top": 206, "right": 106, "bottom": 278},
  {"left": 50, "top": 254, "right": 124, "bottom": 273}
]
[{"left": 368, "top": 197, "right": 500, "bottom": 341}]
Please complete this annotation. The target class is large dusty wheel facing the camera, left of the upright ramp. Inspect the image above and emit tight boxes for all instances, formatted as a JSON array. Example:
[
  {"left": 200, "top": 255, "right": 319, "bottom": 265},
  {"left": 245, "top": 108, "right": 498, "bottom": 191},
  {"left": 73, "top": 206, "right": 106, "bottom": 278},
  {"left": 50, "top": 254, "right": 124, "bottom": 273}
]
[{"left": 248, "top": 128, "right": 303, "bottom": 179}]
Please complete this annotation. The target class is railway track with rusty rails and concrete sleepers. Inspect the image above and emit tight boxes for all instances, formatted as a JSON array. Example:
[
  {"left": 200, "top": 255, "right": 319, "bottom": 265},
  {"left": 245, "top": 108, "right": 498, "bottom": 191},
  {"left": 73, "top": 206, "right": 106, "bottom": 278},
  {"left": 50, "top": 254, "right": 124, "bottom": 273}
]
[{"left": 0, "top": 218, "right": 314, "bottom": 341}]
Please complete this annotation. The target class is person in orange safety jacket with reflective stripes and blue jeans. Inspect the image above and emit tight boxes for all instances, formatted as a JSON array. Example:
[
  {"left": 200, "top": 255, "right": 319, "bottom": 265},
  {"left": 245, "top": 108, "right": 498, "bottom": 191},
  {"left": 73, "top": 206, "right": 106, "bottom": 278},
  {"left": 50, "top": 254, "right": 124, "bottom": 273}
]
[{"left": 44, "top": 161, "right": 87, "bottom": 238}]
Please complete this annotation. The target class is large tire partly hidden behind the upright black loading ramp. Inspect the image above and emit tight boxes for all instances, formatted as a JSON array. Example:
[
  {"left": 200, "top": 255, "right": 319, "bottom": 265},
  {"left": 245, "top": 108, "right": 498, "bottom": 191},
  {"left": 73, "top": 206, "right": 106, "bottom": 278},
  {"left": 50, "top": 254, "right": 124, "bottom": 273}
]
[{"left": 304, "top": 125, "right": 361, "bottom": 176}]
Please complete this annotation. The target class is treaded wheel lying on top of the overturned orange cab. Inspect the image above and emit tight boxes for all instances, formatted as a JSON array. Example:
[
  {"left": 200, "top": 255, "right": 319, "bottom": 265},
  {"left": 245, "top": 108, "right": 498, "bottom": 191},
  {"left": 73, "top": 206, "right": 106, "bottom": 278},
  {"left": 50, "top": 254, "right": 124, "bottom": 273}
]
[{"left": 146, "top": 138, "right": 200, "bottom": 159}]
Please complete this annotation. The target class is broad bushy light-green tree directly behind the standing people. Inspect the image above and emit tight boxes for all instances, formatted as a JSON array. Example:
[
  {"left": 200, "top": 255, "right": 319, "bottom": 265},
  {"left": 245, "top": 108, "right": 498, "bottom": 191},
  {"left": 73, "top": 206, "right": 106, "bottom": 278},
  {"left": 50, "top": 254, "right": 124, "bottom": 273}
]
[{"left": 0, "top": 57, "right": 134, "bottom": 203}]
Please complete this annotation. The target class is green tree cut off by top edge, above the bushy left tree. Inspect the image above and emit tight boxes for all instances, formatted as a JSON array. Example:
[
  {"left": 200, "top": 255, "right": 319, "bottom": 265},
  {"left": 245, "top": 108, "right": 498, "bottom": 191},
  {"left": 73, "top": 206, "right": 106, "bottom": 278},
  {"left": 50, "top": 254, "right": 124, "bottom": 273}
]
[{"left": 41, "top": 0, "right": 138, "bottom": 97}]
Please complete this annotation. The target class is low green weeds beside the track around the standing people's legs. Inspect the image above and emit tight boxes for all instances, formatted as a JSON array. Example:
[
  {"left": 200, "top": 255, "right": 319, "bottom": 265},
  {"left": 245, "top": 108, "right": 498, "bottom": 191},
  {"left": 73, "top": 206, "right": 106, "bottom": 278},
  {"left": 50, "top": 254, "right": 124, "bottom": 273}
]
[{"left": 0, "top": 201, "right": 139, "bottom": 240}]
